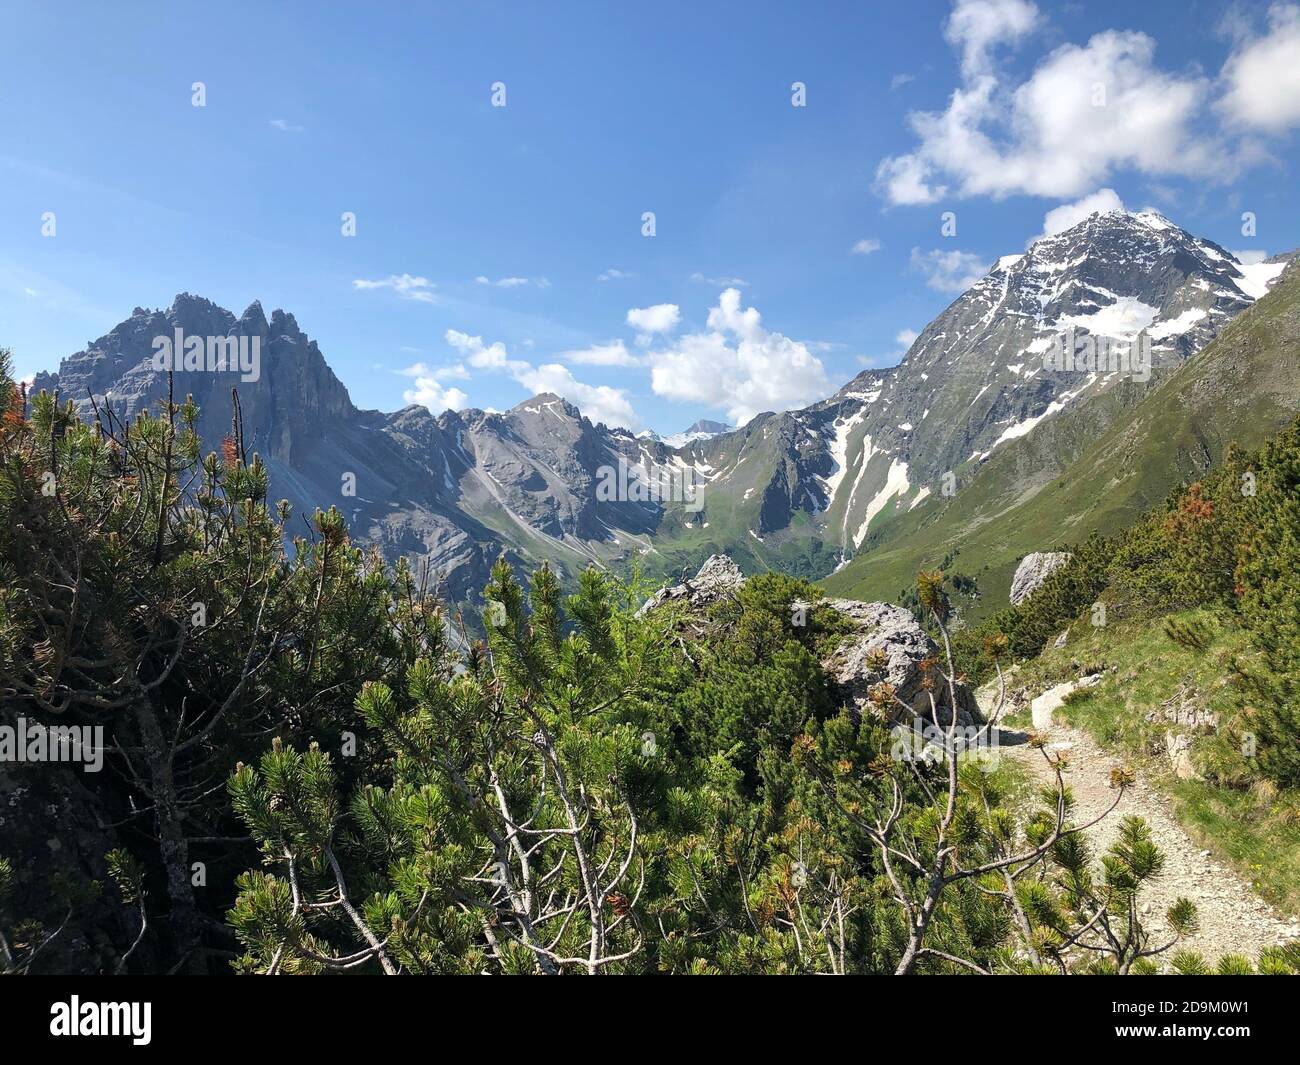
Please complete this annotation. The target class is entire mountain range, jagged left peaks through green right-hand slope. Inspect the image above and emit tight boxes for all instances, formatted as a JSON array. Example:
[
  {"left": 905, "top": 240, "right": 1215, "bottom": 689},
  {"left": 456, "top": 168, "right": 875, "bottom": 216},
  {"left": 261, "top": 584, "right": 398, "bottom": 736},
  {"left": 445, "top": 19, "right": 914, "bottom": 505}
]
[{"left": 25, "top": 212, "right": 1300, "bottom": 611}]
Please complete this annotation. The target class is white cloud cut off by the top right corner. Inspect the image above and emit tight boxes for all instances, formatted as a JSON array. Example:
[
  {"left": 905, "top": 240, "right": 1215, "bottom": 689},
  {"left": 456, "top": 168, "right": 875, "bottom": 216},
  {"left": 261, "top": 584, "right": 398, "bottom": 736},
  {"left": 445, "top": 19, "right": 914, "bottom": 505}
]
[{"left": 1219, "top": 4, "right": 1300, "bottom": 133}]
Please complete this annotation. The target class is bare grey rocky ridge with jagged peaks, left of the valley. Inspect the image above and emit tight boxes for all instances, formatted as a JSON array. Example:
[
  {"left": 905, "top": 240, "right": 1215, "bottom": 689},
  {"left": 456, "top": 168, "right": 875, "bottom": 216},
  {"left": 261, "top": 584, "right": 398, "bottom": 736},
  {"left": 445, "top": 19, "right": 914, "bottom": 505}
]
[{"left": 33, "top": 294, "right": 686, "bottom": 601}]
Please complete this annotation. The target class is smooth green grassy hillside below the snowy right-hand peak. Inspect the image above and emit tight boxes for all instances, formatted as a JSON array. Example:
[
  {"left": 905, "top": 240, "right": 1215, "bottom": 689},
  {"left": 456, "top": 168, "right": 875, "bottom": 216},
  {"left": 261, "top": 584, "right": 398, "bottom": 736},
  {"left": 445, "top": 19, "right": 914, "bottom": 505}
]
[{"left": 823, "top": 269, "right": 1300, "bottom": 616}]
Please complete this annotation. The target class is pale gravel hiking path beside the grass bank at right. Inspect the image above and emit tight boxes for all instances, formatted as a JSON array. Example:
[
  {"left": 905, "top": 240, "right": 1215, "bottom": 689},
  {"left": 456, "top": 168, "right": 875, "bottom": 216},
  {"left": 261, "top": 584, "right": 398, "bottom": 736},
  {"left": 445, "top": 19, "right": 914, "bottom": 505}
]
[{"left": 982, "top": 691, "right": 1300, "bottom": 965}]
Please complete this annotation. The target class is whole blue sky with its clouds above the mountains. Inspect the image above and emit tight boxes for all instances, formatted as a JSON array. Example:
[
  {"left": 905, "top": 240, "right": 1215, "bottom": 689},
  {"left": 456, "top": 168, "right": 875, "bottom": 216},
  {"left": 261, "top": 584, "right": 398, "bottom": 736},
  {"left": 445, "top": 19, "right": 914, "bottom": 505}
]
[{"left": 0, "top": 0, "right": 1300, "bottom": 433}]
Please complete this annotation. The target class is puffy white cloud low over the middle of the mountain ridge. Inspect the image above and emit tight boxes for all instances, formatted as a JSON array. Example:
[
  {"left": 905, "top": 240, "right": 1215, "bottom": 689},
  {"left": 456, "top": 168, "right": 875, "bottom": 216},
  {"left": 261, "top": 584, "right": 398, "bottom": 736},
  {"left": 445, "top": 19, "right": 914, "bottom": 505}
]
[{"left": 650, "top": 289, "right": 831, "bottom": 425}]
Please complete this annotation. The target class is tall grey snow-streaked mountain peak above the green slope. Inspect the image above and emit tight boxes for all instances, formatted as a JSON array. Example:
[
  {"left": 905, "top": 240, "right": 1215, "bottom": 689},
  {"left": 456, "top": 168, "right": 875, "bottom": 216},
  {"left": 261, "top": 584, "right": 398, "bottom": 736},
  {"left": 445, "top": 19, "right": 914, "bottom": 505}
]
[{"left": 686, "top": 211, "right": 1284, "bottom": 553}]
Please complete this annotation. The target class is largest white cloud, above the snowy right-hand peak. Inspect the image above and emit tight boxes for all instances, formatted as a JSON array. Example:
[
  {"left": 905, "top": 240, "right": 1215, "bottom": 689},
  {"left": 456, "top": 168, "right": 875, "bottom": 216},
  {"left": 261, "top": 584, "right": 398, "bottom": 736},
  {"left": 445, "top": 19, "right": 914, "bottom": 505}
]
[{"left": 876, "top": 19, "right": 1227, "bottom": 204}]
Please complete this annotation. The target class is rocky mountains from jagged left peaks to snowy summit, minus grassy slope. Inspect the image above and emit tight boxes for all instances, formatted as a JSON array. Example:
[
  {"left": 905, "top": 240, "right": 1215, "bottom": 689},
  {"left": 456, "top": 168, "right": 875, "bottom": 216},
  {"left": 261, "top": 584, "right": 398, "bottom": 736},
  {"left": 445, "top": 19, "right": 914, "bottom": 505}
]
[{"left": 25, "top": 212, "right": 1283, "bottom": 601}]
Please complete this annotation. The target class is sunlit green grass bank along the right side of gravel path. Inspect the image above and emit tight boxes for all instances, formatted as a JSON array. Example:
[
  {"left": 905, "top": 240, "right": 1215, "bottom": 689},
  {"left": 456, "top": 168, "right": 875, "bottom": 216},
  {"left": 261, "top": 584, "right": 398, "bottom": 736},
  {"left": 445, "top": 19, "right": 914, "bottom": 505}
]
[{"left": 1014, "top": 611, "right": 1300, "bottom": 914}]
